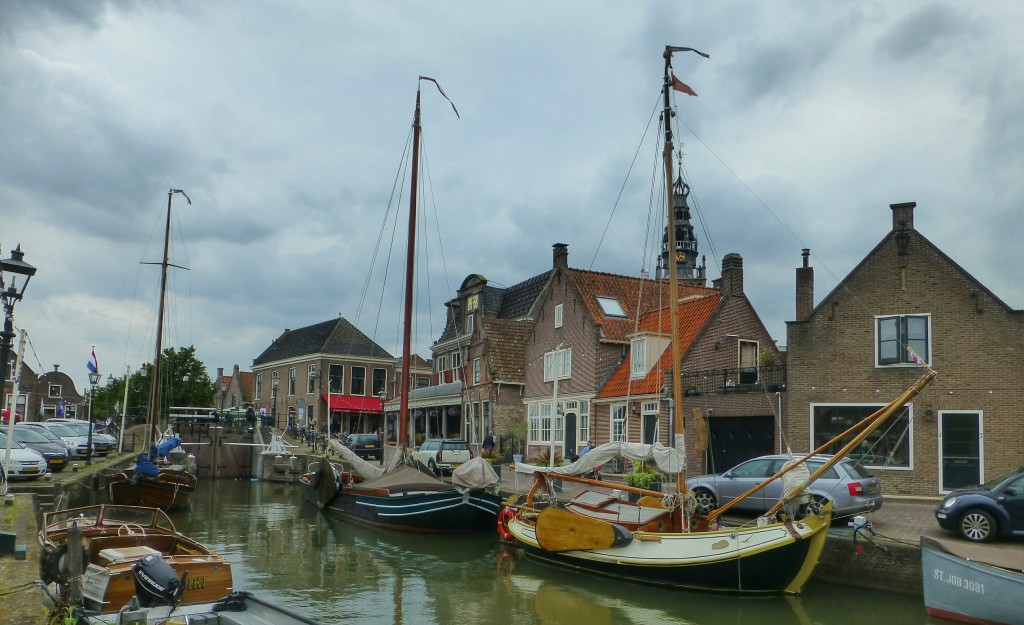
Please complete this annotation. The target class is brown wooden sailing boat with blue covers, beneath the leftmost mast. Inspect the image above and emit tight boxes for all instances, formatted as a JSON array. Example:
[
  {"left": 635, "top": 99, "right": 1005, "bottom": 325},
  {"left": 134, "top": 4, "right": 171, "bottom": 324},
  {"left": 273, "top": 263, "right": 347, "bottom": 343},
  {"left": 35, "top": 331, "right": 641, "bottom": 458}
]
[{"left": 108, "top": 189, "right": 197, "bottom": 511}]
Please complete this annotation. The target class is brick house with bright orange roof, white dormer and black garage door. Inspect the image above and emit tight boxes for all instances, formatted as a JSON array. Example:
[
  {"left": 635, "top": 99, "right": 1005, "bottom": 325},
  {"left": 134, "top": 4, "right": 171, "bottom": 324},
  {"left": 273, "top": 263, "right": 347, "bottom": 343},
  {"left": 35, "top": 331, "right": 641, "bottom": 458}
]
[{"left": 594, "top": 253, "right": 785, "bottom": 474}]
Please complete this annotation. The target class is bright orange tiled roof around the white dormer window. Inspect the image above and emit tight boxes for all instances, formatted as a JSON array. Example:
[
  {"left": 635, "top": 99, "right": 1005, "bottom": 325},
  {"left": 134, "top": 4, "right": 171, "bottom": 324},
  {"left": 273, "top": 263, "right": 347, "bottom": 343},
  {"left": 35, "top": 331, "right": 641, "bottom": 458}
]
[{"left": 597, "top": 289, "right": 722, "bottom": 398}]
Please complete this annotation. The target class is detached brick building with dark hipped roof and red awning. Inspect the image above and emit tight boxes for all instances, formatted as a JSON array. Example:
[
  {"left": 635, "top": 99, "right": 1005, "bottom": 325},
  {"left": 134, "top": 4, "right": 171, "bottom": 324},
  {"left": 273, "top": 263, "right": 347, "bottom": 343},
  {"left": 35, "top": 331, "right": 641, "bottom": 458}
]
[{"left": 252, "top": 318, "right": 401, "bottom": 434}]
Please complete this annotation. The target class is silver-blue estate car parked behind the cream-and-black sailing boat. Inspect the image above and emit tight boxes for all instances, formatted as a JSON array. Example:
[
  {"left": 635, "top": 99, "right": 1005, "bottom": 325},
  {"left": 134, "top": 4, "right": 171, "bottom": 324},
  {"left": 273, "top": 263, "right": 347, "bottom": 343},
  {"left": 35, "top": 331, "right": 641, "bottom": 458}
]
[{"left": 686, "top": 454, "right": 883, "bottom": 517}]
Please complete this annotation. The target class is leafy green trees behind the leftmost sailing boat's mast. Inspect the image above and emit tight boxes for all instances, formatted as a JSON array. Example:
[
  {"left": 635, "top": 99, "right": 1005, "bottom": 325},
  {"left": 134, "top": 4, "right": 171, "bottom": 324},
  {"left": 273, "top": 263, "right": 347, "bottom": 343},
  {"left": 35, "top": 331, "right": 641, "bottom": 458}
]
[{"left": 92, "top": 345, "right": 215, "bottom": 421}]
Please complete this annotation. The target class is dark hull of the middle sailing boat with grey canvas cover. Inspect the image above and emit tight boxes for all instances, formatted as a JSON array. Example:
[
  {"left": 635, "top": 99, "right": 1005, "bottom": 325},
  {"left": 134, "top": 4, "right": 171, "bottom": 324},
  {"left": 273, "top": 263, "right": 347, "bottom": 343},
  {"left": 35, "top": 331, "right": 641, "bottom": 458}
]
[{"left": 313, "top": 487, "right": 503, "bottom": 534}]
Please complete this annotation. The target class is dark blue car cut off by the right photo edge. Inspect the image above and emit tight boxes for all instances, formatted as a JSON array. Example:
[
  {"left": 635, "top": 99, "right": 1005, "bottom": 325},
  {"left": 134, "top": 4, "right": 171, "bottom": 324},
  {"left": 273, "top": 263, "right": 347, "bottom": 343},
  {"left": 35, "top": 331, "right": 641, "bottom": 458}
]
[{"left": 935, "top": 467, "right": 1024, "bottom": 542}]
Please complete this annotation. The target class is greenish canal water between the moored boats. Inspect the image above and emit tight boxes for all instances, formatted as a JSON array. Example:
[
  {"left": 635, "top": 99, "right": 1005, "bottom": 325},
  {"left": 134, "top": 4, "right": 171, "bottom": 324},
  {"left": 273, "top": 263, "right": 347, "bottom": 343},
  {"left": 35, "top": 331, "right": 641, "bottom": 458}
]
[{"left": 174, "top": 480, "right": 930, "bottom": 625}]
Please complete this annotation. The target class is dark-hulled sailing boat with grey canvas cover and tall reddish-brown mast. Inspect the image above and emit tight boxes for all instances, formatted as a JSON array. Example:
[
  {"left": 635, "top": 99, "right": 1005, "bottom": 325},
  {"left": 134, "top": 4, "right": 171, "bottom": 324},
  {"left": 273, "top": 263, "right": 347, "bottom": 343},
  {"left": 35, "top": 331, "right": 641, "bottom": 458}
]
[{"left": 303, "top": 76, "right": 502, "bottom": 533}]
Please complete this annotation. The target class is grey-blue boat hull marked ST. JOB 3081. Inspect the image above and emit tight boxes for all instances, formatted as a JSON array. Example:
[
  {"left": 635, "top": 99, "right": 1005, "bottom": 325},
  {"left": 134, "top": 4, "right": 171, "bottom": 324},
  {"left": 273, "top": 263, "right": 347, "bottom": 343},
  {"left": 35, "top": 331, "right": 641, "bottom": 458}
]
[{"left": 921, "top": 537, "right": 1024, "bottom": 625}]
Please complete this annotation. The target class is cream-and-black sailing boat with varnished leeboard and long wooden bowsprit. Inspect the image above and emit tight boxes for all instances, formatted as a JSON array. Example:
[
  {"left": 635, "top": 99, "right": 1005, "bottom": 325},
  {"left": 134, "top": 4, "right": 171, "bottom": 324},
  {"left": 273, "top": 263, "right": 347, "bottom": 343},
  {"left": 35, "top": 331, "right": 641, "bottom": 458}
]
[{"left": 499, "top": 46, "right": 935, "bottom": 593}]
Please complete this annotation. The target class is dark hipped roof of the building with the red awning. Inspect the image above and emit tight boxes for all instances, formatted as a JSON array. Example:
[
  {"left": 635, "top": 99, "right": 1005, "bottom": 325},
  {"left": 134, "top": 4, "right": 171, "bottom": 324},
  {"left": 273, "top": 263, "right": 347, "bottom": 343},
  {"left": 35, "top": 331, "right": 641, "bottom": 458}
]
[{"left": 253, "top": 318, "right": 394, "bottom": 365}]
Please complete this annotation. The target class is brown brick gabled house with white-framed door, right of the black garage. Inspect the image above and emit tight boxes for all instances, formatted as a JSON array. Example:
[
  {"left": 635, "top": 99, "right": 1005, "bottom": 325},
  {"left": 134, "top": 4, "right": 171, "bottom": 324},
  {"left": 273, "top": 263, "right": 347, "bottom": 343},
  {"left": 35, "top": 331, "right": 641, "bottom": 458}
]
[{"left": 784, "top": 203, "right": 1024, "bottom": 497}]
